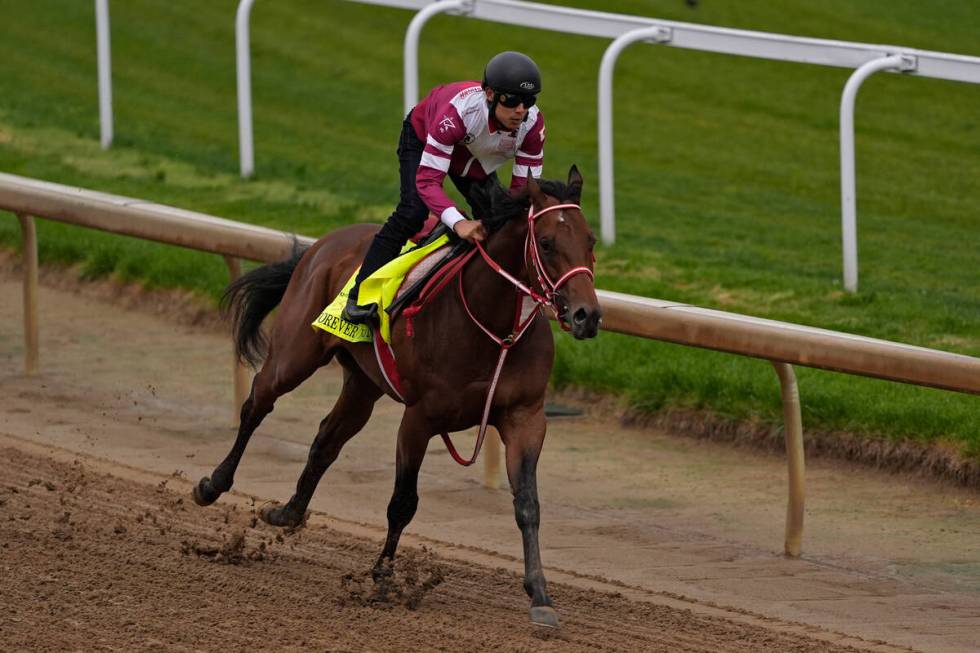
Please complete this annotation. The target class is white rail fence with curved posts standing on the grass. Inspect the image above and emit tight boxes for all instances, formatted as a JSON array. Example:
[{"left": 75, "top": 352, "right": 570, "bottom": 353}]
[{"left": 95, "top": 0, "right": 980, "bottom": 292}]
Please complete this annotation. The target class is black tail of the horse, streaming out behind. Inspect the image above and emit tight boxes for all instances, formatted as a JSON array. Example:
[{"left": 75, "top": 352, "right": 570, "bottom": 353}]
[{"left": 220, "top": 240, "right": 307, "bottom": 367}]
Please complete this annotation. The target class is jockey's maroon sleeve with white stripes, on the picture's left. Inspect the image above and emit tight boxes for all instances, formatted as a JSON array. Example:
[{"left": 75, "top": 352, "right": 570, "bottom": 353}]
[{"left": 415, "top": 103, "right": 466, "bottom": 228}]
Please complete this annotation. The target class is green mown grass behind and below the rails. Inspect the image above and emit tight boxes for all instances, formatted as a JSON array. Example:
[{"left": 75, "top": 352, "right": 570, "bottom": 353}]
[{"left": 0, "top": 0, "right": 980, "bottom": 455}]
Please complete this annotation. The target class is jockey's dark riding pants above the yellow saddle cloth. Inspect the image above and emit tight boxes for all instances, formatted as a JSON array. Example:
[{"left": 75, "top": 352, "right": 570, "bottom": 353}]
[{"left": 350, "top": 111, "right": 471, "bottom": 297}]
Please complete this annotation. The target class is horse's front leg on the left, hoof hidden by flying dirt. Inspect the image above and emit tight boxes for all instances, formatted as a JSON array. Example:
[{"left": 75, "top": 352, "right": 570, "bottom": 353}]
[{"left": 372, "top": 408, "right": 431, "bottom": 581}]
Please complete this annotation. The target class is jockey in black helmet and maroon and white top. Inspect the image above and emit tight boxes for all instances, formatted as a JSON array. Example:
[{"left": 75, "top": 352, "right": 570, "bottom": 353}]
[{"left": 342, "top": 52, "right": 544, "bottom": 323}]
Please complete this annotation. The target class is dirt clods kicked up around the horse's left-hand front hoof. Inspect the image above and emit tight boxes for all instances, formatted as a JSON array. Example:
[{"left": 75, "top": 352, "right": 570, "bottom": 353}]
[{"left": 340, "top": 546, "right": 446, "bottom": 610}]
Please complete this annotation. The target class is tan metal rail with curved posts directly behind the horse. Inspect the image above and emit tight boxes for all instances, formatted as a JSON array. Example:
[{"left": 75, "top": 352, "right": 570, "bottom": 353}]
[{"left": 0, "top": 173, "right": 980, "bottom": 556}]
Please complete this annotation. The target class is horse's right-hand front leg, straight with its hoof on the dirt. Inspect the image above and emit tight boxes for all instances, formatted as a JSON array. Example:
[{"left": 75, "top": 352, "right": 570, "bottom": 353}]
[{"left": 498, "top": 404, "right": 558, "bottom": 628}]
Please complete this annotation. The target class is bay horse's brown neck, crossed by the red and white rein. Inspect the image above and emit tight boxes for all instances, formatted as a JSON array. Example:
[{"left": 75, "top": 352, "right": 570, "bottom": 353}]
[{"left": 463, "top": 217, "right": 528, "bottom": 336}]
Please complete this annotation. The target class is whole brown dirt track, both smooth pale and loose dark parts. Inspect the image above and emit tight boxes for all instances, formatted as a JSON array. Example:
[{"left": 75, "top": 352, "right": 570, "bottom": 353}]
[{"left": 0, "top": 271, "right": 980, "bottom": 653}]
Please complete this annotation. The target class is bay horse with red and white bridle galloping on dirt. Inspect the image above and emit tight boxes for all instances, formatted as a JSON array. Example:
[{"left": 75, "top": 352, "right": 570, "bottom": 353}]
[{"left": 193, "top": 166, "right": 601, "bottom": 627}]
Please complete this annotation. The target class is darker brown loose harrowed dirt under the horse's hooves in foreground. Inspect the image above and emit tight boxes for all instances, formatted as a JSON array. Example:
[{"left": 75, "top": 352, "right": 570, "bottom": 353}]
[{"left": 0, "top": 447, "right": 854, "bottom": 652}]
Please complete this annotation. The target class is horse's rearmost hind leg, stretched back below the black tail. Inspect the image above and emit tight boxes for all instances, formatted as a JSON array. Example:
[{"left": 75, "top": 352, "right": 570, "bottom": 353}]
[{"left": 193, "top": 350, "right": 323, "bottom": 506}]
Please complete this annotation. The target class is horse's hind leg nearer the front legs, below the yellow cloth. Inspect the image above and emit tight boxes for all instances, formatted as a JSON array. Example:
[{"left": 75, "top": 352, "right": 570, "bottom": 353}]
[{"left": 259, "top": 364, "right": 382, "bottom": 527}]
